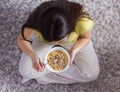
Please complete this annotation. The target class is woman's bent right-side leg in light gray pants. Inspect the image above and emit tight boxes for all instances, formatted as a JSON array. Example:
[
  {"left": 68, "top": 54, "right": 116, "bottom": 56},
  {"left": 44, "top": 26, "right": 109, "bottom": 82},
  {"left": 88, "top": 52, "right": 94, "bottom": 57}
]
[{"left": 43, "top": 42, "right": 99, "bottom": 83}]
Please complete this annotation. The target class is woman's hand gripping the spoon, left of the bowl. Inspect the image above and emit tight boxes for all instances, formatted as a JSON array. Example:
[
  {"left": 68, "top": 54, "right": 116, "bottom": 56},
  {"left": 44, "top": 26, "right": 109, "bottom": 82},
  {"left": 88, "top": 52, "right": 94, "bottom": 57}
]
[{"left": 31, "top": 53, "right": 44, "bottom": 72}]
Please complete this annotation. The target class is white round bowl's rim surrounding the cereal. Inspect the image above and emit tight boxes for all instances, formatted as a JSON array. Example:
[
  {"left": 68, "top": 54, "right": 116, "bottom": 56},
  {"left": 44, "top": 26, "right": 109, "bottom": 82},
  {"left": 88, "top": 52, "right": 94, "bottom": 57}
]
[{"left": 45, "top": 46, "right": 70, "bottom": 73}]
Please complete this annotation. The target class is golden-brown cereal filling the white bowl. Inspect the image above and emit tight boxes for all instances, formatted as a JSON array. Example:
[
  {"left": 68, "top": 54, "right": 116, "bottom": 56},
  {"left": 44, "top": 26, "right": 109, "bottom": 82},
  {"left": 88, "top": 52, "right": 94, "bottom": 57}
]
[{"left": 47, "top": 50, "right": 68, "bottom": 71}]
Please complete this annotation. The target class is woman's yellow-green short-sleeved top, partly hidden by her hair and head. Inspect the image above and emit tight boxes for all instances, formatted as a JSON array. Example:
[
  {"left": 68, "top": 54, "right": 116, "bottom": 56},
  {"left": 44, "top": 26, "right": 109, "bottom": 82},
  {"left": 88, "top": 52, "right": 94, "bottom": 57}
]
[{"left": 34, "top": 9, "right": 94, "bottom": 44}]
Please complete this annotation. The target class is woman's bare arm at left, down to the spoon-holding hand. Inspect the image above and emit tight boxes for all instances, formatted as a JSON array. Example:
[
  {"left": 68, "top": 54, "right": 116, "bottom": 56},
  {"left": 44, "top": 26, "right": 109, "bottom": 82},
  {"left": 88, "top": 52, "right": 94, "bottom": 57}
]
[{"left": 17, "top": 28, "right": 44, "bottom": 71}]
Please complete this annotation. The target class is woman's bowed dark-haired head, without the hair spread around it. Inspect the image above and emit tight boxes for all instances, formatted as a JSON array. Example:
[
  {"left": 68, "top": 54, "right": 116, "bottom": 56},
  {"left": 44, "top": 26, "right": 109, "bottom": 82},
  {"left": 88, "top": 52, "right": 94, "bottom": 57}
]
[{"left": 40, "top": 7, "right": 72, "bottom": 42}]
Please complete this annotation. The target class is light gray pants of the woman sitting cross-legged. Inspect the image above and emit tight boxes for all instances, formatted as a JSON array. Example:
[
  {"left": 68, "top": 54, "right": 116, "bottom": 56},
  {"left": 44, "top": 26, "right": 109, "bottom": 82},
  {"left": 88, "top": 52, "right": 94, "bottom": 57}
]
[{"left": 19, "top": 37, "right": 100, "bottom": 84}]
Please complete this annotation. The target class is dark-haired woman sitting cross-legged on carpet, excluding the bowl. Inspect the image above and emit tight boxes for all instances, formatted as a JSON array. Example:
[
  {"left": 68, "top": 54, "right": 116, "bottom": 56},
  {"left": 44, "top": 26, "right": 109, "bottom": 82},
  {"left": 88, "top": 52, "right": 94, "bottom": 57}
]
[{"left": 17, "top": 0, "right": 99, "bottom": 84}]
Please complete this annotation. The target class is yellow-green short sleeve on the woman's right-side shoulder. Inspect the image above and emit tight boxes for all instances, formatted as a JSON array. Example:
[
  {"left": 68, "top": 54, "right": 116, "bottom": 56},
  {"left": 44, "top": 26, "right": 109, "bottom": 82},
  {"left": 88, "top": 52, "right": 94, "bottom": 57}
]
[{"left": 75, "top": 18, "right": 94, "bottom": 35}]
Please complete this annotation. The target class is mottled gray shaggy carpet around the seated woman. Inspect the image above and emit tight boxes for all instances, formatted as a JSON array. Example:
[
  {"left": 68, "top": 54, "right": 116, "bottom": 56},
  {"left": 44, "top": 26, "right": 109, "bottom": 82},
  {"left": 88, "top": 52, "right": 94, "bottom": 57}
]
[{"left": 0, "top": 0, "right": 120, "bottom": 92}]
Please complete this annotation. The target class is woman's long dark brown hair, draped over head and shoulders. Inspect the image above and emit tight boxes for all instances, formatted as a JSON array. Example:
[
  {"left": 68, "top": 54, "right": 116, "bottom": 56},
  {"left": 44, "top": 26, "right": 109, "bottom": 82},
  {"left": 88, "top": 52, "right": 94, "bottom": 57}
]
[{"left": 22, "top": 0, "right": 85, "bottom": 42}]
